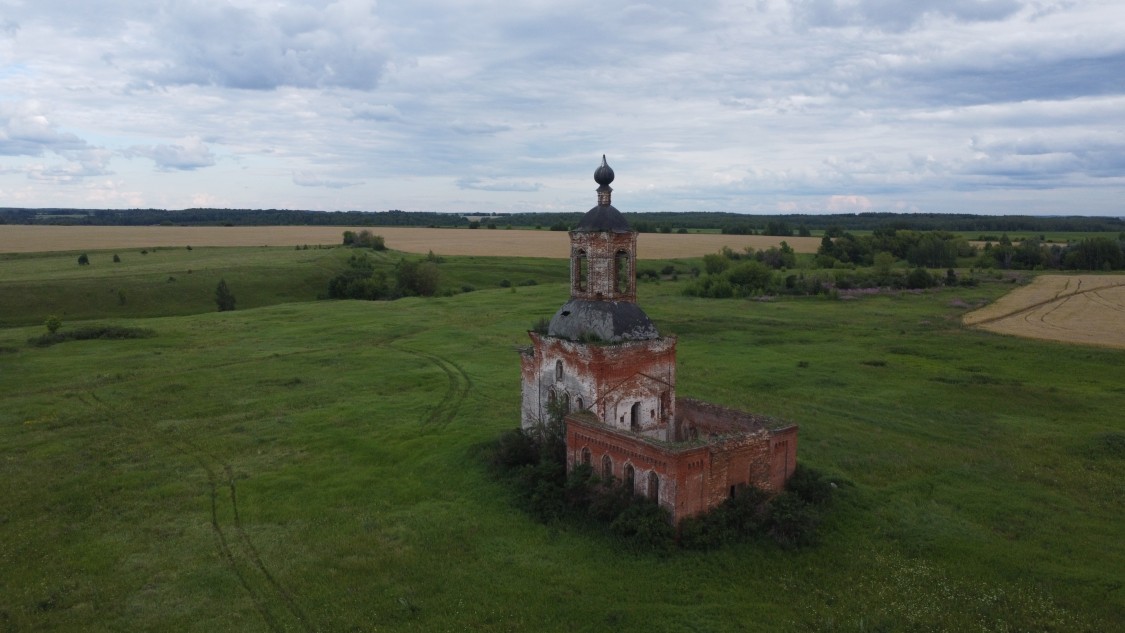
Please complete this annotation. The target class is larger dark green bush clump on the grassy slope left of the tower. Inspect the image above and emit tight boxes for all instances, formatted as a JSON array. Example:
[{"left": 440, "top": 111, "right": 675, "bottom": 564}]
[{"left": 327, "top": 253, "right": 441, "bottom": 301}]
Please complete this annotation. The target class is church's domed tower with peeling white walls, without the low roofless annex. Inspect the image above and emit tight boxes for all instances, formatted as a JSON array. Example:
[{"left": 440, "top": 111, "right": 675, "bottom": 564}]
[{"left": 521, "top": 155, "right": 676, "bottom": 438}]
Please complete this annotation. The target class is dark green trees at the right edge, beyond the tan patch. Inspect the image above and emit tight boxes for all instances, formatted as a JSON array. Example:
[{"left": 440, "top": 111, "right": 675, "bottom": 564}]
[{"left": 977, "top": 233, "right": 1125, "bottom": 270}]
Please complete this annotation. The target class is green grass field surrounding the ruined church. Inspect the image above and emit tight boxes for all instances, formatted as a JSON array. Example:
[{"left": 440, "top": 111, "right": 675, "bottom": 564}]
[{"left": 0, "top": 248, "right": 1125, "bottom": 632}]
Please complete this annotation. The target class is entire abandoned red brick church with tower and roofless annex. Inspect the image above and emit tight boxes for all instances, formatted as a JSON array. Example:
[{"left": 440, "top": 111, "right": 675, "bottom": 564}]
[{"left": 521, "top": 156, "right": 798, "bottom": 523}]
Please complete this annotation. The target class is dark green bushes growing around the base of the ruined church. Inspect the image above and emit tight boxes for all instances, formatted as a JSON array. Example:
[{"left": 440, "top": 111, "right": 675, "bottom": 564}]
[{"left": 491, "top": 410, "right": 831, "bottom": 552}]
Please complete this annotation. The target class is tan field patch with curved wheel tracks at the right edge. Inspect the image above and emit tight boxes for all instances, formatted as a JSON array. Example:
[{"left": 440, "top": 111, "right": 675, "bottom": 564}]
[{"left": 963, "top": 274, "right": 1125, "bottom": 349}]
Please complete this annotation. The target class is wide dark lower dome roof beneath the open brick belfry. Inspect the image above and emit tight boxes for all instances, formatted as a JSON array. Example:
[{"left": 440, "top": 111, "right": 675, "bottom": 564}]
[{"left": 547, "top": 299, "right": 660, "bottom": 343}]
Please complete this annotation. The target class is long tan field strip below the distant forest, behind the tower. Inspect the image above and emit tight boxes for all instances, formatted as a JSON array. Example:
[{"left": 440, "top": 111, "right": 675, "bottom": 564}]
[{"left": 0, "top": 225, "right": 820, "bottom": 260}]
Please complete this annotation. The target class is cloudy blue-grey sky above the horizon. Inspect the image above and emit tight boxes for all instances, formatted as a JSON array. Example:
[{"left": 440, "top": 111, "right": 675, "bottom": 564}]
[{"left": 0, "top": 0, "right": 1125, "bottom": 216}]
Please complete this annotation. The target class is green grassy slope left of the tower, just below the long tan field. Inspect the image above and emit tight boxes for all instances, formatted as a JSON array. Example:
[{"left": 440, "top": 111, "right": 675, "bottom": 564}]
[{"left": 0, "top": 246, "right": 568, "bottom": 327}]
